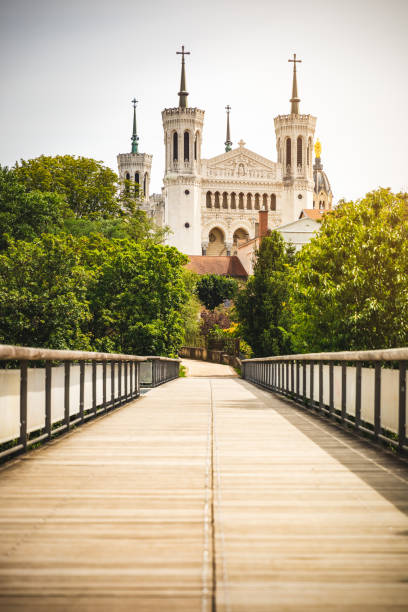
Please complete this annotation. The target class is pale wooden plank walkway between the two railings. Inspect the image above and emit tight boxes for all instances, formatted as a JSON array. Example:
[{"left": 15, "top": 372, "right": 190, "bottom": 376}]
[{"left": 0, "top": 364, "right": 408, "bottom": 612}]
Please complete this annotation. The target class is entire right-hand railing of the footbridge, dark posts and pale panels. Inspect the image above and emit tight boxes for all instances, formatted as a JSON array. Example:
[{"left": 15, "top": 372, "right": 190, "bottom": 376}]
[{"left": 242, "top": 348, "right": 408, "bottom": 451}]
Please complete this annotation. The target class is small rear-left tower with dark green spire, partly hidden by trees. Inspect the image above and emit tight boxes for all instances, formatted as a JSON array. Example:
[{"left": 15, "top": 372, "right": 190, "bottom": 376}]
[{"left": 117, "top": 98, "right": 153, "bottom": 201}]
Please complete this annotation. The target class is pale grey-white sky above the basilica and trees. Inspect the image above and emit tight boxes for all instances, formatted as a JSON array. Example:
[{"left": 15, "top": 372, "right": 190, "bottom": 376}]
[{"left": 0, "top": 0, "right": 408, "bottom": 202}]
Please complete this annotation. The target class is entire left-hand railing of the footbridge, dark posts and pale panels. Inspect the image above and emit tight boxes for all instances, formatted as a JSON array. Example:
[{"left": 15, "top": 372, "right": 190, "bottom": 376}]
[{"left": 0, "top": 345, "right": 180, "bottom": 458}]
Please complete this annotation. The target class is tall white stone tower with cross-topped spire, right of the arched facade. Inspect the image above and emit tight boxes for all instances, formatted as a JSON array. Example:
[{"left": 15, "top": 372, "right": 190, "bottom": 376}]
[{"left": 274, "top": 53, "right": 316, "bottom": 223}]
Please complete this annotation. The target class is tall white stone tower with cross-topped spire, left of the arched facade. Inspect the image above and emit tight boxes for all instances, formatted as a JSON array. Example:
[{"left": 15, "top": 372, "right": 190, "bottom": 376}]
[{"left": 162, "top": 45, "right": 204, "bottom": 255}]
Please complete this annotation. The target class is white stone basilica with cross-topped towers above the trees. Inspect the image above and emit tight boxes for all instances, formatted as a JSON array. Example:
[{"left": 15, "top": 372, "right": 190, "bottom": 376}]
[{"left": 117, "top": 46, "right": 333, "bottom": 256}]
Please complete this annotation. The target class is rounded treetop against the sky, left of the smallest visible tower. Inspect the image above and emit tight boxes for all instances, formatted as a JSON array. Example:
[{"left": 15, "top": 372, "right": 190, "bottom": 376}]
[{"left": 14, "top": 155, "right": 121, "bottom": 217}]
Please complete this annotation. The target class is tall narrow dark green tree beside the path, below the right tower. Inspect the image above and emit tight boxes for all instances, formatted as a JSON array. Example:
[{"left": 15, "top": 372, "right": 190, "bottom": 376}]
[{"left": 235, "top": 231, "right": 294, "bottom": 357}]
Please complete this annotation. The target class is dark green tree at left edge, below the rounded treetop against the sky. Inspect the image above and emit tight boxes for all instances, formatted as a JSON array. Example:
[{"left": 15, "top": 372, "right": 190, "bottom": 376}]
[{"left": 0, "top": 166, "right": 67, "bottom": 249}]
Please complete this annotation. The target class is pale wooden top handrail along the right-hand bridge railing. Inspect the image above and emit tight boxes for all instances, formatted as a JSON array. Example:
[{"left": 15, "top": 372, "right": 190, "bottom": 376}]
[{"left": 242, "top": 347, "right": 408, "bottom": 362}]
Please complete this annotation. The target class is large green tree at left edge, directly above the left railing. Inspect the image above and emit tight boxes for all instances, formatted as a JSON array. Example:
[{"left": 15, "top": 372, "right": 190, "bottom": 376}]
[{"left": 0, "top": 235, "right": 91, "bottom": 350}]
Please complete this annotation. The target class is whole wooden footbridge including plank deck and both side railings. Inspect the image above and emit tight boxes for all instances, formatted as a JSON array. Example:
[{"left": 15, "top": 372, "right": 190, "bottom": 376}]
[{"left": 0, "top": 347, "right": 408, "bottom": 612}]
